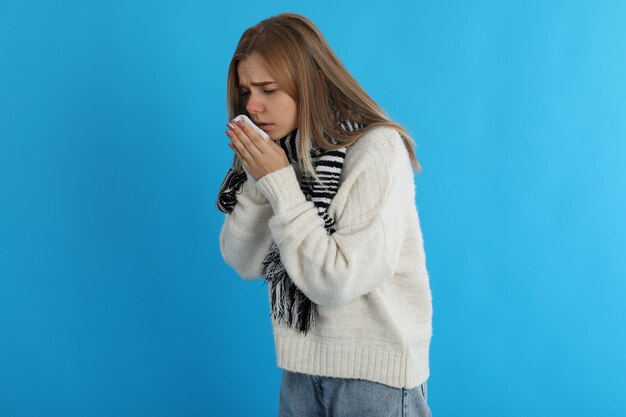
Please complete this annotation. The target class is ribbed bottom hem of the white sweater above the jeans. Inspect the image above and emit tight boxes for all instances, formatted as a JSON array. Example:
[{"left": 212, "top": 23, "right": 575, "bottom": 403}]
[{"left": 274, "top": 334, "right": 429, "bottom": 389}]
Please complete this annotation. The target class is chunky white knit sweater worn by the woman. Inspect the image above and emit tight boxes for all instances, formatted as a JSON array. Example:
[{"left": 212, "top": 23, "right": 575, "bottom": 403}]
[{"left": 220, "top": 128, "right": 432, "bottom": 388}]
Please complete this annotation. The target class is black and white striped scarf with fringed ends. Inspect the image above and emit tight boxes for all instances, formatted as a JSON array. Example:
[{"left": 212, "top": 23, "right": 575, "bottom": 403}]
[{"left": 216, "top": 121, "right": 363, "bottom": 335}]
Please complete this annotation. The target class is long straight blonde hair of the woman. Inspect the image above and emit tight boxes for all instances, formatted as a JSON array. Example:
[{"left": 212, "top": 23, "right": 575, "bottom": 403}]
[{"left": 226, "top": 13, "right": 421, "bottom": 178}]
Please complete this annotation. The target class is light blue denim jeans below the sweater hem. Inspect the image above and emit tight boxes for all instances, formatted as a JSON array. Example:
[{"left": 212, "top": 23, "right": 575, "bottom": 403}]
[{"left": 278, "top": 369, "right": 432, "bottom": 417}]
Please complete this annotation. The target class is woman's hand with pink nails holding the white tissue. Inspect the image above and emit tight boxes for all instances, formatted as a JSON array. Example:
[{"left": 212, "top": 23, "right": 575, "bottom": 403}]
[{"left": 226, "top": 121, "right": 289, "bottom": 181}]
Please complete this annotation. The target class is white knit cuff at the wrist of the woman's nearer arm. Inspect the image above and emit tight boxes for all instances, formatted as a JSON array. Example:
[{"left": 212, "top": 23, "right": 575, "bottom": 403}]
[{"left": 256, "top": 165, "right": 306, "bottom": 214}]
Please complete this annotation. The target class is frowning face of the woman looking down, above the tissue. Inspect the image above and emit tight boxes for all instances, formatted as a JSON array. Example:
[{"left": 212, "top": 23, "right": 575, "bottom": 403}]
[{"left": 237, "top": 53, "right": 298, "bottom": 140}]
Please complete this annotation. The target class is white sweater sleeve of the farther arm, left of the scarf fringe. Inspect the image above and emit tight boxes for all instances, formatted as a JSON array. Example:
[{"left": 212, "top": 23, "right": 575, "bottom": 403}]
[{"left": 220, "top": 175, "right": 272, "bottom": 279}]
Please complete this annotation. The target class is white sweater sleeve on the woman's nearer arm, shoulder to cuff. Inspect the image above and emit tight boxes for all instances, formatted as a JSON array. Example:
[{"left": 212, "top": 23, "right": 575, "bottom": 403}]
[{"left": 257, "top": 131, "right": 414, "bottom": 306}]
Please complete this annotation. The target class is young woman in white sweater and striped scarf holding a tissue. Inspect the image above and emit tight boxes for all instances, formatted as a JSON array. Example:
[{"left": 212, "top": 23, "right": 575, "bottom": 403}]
[{"left": 217, "top": 13, "right": 432, "bottom": 417}]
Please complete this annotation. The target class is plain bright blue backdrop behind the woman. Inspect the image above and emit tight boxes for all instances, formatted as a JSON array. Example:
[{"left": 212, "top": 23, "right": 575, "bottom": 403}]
[{"left": 0, "top": 0, "right": 626, "bottom": 417}]
